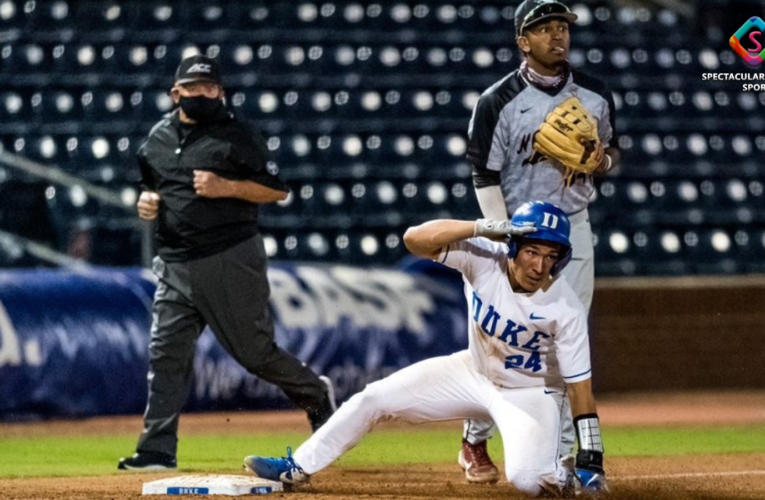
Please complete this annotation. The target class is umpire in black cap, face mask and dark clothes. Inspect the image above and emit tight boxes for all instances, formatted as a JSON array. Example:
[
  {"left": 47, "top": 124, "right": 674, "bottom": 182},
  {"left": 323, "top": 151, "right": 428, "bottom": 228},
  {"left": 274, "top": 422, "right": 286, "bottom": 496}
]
[{"left": 119, "top": 55, "right": 334, "bottom": 470}]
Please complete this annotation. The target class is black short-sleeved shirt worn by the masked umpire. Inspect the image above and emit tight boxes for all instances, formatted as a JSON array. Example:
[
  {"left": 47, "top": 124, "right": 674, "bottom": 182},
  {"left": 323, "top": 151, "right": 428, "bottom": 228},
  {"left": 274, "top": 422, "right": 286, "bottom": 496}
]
[{"left": 138, "top": 107, "right": 289, "bottom": 262}]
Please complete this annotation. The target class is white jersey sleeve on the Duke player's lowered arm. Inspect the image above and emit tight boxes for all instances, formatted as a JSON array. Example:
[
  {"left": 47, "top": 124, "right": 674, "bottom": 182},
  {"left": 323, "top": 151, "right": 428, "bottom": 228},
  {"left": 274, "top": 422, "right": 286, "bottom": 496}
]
[{"left": 556, "top": 310, "right": 592, "bottom": 384}]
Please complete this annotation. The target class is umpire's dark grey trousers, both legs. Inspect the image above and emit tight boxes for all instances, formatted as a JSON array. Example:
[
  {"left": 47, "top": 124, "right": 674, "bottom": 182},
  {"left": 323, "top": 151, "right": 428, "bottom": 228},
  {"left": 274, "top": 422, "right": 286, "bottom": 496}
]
[{"left": 137, "top": 235, "right": 327, "bottom": 456}]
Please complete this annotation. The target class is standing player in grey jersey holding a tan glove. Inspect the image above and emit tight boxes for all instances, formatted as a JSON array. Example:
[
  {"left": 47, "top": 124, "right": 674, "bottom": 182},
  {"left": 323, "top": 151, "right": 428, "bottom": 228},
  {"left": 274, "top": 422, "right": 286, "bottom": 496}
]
[{"left": 458, "top": 0, "right": 619, "bottom": 483}]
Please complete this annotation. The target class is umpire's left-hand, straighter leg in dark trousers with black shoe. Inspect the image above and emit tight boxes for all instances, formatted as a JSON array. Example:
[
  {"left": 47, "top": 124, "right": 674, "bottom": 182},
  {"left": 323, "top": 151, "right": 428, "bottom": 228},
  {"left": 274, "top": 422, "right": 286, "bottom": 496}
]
[{"left": 119, "top": 258, "right": 204, "bottom": 470}]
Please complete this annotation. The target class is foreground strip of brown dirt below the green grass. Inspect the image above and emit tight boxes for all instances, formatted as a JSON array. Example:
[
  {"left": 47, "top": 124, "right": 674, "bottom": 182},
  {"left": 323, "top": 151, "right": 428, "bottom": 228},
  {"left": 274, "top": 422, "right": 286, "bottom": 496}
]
[{"left": 0, "top": 454, "right": 765, "bottom": 500}]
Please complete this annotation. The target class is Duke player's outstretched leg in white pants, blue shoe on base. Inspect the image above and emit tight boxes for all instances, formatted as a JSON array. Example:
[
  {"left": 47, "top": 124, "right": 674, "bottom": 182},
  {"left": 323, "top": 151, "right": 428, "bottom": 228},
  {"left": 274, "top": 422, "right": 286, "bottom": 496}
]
[{"left": 245, "top": 351, "right": 496, "bottom": 480}]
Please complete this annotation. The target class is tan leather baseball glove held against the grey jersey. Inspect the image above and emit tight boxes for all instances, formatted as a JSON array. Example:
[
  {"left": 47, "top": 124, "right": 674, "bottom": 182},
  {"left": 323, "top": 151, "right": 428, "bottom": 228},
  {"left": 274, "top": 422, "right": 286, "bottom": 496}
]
[{"left": 534, "top": 97, "right": 605, "bottom": 185}]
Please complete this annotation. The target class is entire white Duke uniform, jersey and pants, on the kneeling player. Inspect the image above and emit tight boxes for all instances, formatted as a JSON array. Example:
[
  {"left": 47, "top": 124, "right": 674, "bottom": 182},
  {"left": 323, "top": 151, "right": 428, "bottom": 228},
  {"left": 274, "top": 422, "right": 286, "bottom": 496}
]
[{"left": 294, "top": 238, "right": 590, "bottom": 496}]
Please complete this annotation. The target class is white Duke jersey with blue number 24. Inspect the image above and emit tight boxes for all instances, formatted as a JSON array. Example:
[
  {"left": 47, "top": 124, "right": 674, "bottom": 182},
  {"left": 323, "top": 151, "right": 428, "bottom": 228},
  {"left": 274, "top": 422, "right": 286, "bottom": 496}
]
[{"left": 439, "top": 238, "right": 591, "bottom": 389}]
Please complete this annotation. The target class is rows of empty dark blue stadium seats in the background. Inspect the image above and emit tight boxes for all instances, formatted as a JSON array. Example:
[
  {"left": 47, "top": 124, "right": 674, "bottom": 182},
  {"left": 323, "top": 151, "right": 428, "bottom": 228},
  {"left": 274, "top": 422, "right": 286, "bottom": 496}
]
[{"left": 0, "top": 0, "right": 765, "bottom": 276}]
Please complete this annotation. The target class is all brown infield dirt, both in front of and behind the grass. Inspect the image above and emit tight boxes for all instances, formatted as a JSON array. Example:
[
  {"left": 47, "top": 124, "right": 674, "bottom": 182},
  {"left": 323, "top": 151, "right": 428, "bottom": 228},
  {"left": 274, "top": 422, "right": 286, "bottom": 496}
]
[{"left": 0, "top": 391, "right": 765, "bottom": 500}]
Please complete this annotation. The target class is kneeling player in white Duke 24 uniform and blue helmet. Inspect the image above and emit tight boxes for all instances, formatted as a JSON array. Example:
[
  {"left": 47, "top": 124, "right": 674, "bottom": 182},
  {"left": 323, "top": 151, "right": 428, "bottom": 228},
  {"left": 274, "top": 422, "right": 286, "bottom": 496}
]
[{"left": 244, "top": 202, "right": 607, "bottom": 496}]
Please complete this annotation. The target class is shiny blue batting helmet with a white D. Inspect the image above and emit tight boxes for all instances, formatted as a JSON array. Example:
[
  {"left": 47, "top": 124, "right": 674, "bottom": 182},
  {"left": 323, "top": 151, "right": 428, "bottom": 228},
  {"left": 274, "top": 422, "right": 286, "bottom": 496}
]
[{"left": 507, "top": 201, "right": 572, "bottom": 277}]
